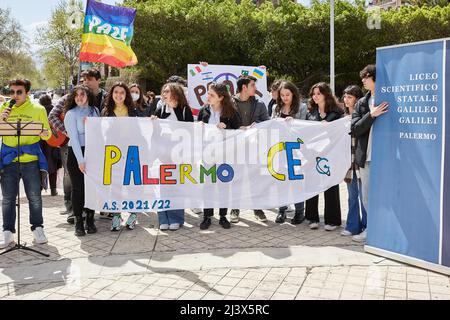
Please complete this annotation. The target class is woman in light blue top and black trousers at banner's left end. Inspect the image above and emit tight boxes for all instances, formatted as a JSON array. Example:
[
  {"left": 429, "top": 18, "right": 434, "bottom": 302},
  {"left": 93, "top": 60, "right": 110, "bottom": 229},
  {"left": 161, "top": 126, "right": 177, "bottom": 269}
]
[{"left": 64, "top": 85, "right": 100, "bottom": 237}]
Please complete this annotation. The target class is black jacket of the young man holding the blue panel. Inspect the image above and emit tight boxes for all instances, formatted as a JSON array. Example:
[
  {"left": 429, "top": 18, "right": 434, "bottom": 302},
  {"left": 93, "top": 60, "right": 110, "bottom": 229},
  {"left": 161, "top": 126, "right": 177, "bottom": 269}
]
[{"left": 352, "top": 91, "right": 375, "bottom": 168}]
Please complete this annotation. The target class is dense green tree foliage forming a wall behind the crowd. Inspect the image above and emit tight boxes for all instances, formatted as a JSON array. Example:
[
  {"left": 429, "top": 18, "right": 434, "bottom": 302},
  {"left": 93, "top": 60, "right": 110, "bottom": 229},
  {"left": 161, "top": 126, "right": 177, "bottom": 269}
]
[{"left": 125, "top": 0, "right": 450, "bottom": 95}]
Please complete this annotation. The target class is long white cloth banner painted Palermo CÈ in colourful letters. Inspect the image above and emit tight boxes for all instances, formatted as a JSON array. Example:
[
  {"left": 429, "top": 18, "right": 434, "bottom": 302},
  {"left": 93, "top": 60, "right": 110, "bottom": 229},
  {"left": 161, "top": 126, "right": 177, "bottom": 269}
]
[{"left": 85, "top": 117, "right": 350, "bottom": 212}]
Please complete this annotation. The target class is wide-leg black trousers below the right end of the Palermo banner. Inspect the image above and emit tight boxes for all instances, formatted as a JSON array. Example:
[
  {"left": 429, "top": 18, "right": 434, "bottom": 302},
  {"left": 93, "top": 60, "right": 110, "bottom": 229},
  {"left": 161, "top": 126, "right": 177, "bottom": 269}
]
[{"left": 305, "top": 185, "right": 342, "bottom": 226}]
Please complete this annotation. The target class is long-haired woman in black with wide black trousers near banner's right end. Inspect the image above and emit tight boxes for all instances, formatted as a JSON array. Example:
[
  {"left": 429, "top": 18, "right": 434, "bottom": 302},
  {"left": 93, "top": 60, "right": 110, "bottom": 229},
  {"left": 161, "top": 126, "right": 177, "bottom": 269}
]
[{"left": 306, "top": 82, "right": 344, "bottom": 231}]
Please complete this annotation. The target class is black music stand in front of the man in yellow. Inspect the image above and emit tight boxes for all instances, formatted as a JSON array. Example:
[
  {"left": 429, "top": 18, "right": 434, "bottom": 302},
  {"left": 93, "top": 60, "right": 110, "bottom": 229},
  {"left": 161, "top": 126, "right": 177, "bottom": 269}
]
[{"left": 0, "top": 119, "right": 50, "bottom": 257}]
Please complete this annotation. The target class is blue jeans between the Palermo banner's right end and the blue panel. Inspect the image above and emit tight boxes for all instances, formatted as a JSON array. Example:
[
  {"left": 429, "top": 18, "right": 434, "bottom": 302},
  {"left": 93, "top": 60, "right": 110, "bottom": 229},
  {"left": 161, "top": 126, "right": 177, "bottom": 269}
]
[{"left": 345, "top": 172, "right": 367, "bottom": 234}]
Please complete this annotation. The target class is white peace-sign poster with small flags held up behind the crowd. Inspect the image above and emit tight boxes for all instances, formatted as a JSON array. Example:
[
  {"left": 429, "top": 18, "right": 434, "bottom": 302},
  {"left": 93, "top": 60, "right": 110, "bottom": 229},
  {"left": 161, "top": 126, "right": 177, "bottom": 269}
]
[{"left": 188, "top": 64, "right": 270, "bottom": 115}]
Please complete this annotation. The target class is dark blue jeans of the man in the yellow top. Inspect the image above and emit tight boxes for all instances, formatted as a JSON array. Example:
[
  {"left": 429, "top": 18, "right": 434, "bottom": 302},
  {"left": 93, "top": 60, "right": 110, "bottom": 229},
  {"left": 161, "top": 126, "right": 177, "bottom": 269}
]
[{"left": 1, "top": 161, "right": 44, "bottom": 233}]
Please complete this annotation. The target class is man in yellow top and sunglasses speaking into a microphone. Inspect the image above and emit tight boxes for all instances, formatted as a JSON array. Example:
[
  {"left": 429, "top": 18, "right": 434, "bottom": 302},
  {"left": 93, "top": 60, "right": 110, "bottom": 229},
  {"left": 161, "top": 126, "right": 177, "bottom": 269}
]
[{"left": 0, "top": 79, "right": 51, "bottom": 248}]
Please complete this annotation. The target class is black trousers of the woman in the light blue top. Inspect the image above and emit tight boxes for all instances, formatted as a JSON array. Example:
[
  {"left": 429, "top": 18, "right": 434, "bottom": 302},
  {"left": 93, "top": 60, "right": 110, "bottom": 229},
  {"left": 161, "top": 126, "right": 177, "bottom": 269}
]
[{"left": 67, "top": 147, "right": 95, "bottom": 217}]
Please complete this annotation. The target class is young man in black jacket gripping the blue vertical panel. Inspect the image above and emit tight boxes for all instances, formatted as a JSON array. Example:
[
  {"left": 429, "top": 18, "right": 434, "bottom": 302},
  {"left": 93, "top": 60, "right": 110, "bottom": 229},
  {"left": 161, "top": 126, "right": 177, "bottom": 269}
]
[{"left": 352, "top": 64, "right": 389, "bottom": 241}]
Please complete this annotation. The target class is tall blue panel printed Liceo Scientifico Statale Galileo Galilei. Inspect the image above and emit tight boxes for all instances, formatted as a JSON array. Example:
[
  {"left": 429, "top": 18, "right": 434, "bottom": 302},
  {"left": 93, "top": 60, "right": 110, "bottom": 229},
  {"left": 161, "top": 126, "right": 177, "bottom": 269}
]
[{"left": 366, "top": 39, "right": 450, "bottom": 274}]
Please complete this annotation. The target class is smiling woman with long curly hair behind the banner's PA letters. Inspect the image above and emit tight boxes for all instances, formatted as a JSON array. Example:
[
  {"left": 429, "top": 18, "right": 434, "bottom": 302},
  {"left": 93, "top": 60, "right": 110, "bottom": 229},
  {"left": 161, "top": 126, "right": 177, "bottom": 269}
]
[{"left": 102, "top": 82, "right": 137, "bottom": 231}]
